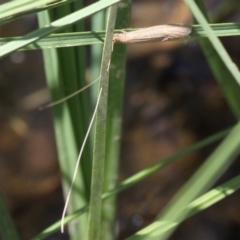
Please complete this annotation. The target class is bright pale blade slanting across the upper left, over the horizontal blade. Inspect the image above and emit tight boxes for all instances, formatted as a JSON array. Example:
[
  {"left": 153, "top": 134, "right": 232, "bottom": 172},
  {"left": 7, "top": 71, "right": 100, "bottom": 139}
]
[{"left": 0, "top": 0, "right": 120, "bottom": 58}]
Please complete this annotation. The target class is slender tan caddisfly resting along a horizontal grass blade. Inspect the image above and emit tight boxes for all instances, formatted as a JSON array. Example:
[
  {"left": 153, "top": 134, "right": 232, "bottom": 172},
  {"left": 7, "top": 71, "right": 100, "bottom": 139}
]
[{"left": 113, "top": 24, "right": 192, "bottom": 44}]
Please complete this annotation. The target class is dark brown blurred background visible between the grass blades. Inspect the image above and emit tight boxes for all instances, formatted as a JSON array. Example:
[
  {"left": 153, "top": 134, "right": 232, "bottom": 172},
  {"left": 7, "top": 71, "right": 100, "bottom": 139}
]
[{"left": 0, "top": 0, "right": 240, "bottom": 240}]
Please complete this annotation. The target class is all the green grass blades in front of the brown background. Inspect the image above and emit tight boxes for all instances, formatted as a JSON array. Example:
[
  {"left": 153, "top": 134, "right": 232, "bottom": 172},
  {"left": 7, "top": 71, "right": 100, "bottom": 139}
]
[{"left": 0, "top": 0, "right": 240, "bottom": 240}]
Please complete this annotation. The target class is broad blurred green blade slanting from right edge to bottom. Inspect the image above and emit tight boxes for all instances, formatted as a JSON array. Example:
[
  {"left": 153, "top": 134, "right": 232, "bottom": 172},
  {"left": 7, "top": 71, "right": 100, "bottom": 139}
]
[{"left": 129, "top": 122, "right": 240, "bottom": 240}]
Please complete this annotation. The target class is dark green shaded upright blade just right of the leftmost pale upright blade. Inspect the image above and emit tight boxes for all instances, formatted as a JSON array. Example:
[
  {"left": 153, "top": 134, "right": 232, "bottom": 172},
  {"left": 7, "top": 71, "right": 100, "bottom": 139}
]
[{"left": 54, "top": 1, "right": 91, "bottom": 240}]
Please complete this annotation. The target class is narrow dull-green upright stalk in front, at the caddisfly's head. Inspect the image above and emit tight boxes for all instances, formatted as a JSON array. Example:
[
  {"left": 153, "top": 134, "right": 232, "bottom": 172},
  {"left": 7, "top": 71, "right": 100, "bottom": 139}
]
[{"left": 88, "top": 5, "right": 117, "bottom": 240}]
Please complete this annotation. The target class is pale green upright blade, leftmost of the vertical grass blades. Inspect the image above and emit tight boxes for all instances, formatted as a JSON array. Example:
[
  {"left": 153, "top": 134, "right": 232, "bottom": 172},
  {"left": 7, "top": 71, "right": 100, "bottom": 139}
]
[{"left": 36, "top": 9, "right": 86, "bottom": 238}]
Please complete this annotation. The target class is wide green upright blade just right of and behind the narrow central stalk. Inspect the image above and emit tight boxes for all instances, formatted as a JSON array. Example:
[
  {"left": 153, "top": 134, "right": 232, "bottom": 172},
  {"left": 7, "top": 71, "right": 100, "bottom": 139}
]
[{"left": 101, "top": 0, "right": 131, "bottom": 240}]
